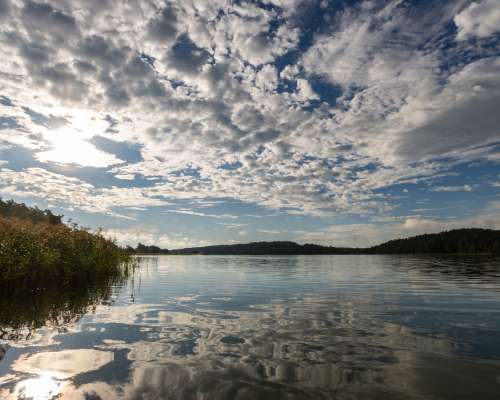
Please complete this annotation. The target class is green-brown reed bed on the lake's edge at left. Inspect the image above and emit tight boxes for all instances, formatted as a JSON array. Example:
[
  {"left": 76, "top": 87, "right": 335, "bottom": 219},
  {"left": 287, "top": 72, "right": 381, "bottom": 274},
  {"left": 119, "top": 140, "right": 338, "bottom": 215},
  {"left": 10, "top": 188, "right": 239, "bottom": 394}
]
[{"left": 0, "top": 216, "right": 132, "bottom": 284}]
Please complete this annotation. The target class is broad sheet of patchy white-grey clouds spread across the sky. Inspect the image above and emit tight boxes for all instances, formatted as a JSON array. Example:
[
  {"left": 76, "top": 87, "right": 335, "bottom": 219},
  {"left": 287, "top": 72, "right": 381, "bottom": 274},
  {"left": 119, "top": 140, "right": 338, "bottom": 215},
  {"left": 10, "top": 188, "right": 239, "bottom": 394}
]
[{"left": 0, "top": 0, "right": 500, "bottom": 231}]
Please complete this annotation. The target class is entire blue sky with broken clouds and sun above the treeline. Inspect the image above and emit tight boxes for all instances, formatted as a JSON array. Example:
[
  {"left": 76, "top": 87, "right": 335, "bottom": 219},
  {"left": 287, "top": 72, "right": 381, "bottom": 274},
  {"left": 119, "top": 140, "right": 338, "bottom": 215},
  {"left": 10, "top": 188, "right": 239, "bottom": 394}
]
[{"left": 0, "top": 0, "right": 500, "bottom": 248}]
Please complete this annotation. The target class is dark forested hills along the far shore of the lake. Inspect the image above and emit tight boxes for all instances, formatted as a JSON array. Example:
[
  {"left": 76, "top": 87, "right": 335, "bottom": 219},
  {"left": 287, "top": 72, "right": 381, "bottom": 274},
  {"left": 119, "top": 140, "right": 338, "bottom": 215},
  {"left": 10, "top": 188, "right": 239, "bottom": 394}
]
[{"left": 170, "top": 228, "right": 500, "bottom": 255}]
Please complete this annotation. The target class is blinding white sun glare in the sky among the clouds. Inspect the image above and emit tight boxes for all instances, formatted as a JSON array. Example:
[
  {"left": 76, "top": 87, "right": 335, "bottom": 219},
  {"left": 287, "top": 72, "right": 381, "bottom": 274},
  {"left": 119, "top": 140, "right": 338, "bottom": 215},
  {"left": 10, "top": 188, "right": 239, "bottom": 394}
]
[{"left": 36, "top": 129, "right": 122, "bottom": 168}]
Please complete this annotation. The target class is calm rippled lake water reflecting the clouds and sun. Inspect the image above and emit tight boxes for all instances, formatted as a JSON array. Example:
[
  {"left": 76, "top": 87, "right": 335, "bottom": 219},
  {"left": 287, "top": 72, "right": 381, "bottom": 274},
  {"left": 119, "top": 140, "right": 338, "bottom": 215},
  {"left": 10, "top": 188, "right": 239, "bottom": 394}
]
[{"left": 0, "top": 256, "right": 500, "bottom": 400}]
